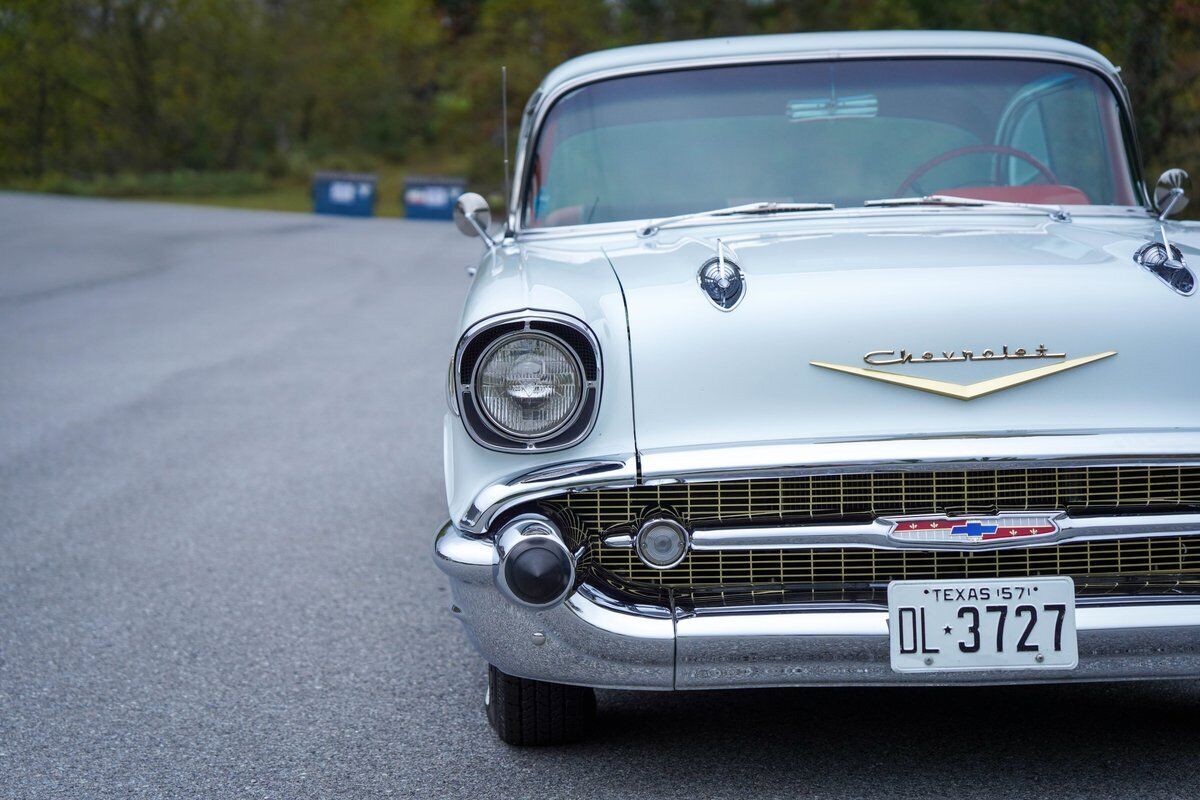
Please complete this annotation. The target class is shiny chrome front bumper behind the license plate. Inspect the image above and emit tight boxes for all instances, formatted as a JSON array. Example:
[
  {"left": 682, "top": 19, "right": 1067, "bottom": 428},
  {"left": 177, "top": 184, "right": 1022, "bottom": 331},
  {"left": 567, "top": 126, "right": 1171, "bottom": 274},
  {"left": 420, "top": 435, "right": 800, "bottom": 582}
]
[{"left": 433, "top": 523, "right": 1200, "bottom": 690}]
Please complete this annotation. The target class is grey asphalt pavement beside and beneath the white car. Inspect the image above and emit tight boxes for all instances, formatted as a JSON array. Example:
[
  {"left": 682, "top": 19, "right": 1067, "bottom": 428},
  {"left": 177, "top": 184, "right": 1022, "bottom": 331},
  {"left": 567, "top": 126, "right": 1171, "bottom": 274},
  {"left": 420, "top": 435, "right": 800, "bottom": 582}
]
[{"left": 0, "top": 194, "right": 1200, "bottom": 800}]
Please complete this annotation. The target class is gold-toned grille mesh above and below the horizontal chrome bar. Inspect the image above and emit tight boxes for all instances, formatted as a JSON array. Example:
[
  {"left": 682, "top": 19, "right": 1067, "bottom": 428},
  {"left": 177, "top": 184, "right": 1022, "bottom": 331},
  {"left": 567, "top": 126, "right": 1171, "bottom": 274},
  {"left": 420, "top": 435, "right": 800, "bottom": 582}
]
[{"left": 542, "top": 465, "right": 1200, "bottom": 594}]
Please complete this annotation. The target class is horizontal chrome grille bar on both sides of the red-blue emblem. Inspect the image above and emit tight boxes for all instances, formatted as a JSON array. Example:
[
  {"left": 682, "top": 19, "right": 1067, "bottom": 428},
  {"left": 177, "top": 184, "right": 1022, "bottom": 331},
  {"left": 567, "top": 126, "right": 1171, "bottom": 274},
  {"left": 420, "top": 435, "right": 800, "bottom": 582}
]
[{"left": 686, "top": 513, "right": 1200, "bottom": 552}]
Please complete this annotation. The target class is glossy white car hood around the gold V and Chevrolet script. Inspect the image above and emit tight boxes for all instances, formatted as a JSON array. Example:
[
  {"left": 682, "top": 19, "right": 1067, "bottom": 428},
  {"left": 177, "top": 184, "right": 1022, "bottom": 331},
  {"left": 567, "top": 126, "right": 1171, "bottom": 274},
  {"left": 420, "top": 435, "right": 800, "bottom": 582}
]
[{"left": 605, "top": 212, "right": 1200, "bottom": 460}]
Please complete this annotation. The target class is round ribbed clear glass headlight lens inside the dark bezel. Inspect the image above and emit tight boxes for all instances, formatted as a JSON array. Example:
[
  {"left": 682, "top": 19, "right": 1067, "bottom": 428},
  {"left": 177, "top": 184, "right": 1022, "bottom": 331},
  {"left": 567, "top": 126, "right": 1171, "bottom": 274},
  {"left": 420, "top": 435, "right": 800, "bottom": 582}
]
[{"left": 475, "top": 333, "right": 583, "bottom": 439}]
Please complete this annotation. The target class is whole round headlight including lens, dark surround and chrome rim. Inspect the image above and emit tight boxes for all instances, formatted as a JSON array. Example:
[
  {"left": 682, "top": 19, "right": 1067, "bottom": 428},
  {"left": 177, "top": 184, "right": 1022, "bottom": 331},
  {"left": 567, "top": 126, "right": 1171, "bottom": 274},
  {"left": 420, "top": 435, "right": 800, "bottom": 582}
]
[{"left": 452, "top": 311, "right": 602, "bottom": 452}]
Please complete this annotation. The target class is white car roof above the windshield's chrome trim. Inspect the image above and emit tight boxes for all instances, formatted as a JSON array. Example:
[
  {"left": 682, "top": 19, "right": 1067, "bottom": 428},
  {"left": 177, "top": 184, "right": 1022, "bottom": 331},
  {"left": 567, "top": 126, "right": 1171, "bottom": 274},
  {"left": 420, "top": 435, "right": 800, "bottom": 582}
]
[{"left": 541, "top": 30, "right": 1118, "bottom": 94}]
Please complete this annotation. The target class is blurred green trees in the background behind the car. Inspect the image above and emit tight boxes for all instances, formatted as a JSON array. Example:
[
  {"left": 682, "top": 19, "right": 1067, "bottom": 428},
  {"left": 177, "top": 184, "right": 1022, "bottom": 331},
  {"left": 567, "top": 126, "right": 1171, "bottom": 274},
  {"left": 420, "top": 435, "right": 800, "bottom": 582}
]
[{"left": 0, "top": 0, "right": 1200, "bottom": 212}]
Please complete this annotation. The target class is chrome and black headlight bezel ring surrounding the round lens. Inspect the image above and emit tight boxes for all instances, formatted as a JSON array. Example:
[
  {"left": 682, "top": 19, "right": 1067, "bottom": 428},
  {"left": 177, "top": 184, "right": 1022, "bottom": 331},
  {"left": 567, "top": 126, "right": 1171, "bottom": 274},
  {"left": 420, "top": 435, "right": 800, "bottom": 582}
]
[{"left": 454, "top": 312, "right": 602, "bottom": 452}]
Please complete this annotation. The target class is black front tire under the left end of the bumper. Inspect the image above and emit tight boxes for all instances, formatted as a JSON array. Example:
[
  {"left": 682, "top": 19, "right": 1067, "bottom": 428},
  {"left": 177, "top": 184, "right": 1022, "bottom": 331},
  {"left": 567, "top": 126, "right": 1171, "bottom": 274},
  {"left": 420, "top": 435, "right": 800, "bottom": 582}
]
[{"left": 487, "top": 664, "right": 596, "bottom": 746}]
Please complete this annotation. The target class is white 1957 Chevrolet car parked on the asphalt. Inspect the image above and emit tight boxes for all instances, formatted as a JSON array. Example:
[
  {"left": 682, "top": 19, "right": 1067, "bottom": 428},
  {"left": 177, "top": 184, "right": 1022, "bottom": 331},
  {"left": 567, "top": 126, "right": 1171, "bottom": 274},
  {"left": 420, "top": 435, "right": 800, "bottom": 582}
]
[{"left": 434, "top": 32, "right": 1200, "bottom": 744}]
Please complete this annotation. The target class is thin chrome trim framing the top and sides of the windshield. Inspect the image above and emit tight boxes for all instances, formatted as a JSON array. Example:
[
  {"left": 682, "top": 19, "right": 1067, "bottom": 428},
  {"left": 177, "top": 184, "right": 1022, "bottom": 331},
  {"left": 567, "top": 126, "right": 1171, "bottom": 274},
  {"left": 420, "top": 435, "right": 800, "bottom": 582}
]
[{"left": 508, "top": 48, "right": 1148, "bottom": 237}]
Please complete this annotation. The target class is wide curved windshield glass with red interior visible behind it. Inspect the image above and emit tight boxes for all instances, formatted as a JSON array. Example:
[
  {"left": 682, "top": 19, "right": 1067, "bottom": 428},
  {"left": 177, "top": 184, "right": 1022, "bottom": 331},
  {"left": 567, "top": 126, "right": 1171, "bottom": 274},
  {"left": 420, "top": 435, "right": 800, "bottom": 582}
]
[{"left": 522, "top": 59, "right": 1136, "bottom": 228}]
